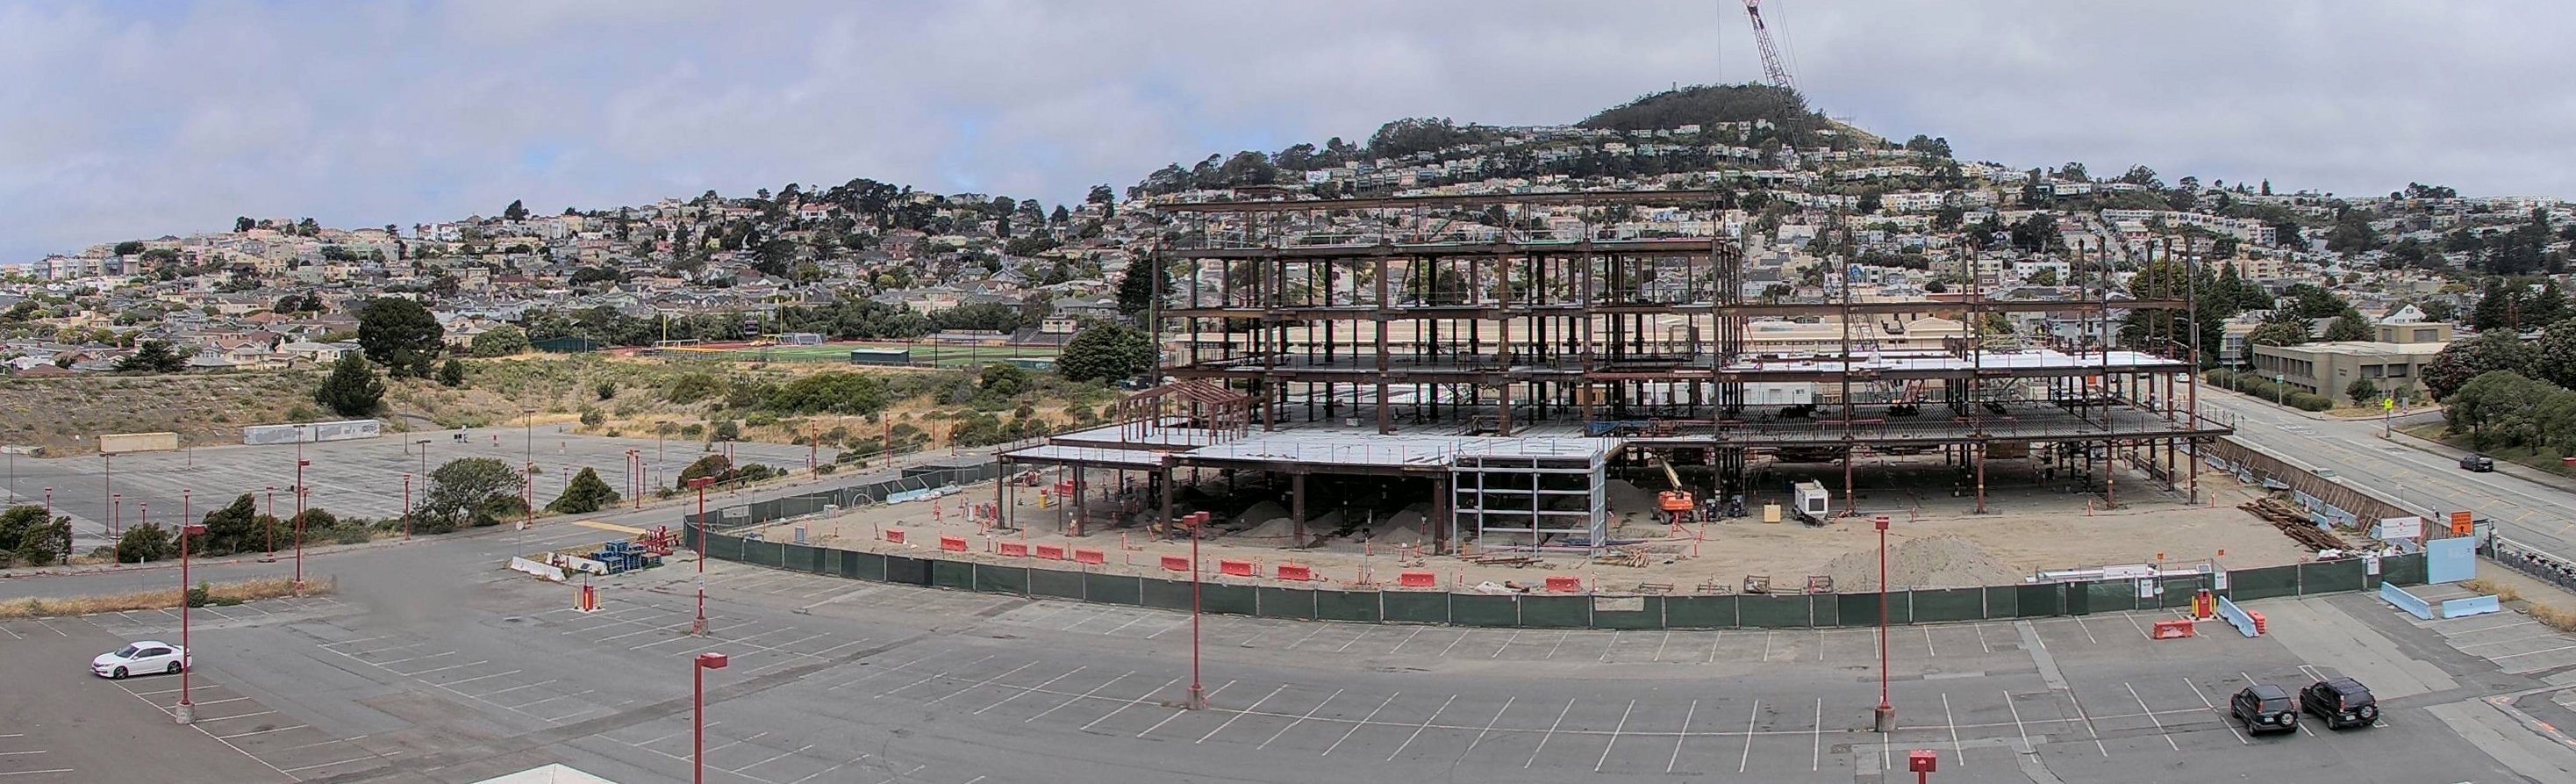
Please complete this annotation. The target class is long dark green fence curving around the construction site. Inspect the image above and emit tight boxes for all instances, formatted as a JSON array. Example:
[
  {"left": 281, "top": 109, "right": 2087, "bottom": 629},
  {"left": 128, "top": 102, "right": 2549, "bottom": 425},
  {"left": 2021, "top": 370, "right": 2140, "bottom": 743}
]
[{"left": 683, "top": 485, "right": 2424, "bottom": 629}]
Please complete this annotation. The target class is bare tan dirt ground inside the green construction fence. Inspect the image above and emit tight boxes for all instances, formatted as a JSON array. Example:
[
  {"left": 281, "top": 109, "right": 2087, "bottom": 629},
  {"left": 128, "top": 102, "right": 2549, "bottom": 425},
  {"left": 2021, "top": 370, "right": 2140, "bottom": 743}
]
[{"left": 755, "top": 456, "right": 2311, "bottom": 593}]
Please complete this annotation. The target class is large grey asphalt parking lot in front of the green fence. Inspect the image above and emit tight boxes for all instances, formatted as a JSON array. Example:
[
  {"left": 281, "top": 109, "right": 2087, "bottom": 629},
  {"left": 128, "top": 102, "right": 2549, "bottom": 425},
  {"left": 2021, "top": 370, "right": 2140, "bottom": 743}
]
[{"left": 0, "top": 543, "right": 2555, "bottom": 784}]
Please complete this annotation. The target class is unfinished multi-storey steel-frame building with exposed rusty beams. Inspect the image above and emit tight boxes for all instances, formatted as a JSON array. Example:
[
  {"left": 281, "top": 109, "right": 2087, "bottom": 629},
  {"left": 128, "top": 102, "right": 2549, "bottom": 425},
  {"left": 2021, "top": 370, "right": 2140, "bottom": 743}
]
[{"left": 1002, "top": 191, "right": 2229, "bottom": 552}]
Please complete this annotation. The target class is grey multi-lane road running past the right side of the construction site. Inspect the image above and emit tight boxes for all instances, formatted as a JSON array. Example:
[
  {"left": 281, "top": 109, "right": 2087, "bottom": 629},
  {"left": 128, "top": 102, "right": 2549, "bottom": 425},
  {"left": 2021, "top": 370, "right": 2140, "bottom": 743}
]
[{"left": 2200, "top": 390, "right": 2576, "bottom": 557}]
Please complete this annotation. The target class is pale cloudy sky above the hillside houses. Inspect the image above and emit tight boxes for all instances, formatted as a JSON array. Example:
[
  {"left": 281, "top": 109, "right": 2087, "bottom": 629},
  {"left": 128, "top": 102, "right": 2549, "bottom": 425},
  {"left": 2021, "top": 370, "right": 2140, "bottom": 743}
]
[{"left": 0, "top": 0, "right": 2576, "bottom": 263}]
